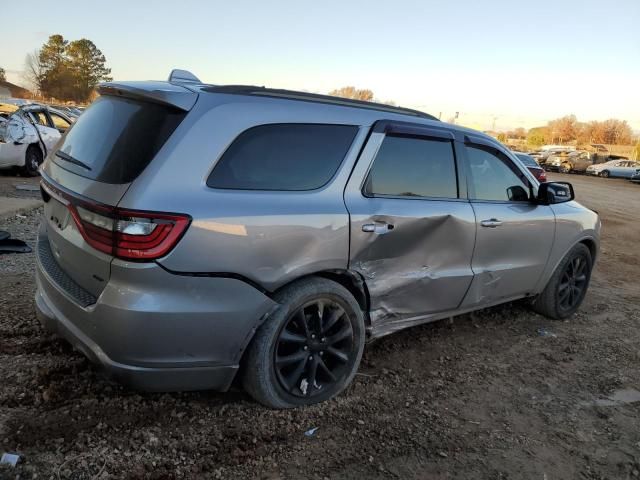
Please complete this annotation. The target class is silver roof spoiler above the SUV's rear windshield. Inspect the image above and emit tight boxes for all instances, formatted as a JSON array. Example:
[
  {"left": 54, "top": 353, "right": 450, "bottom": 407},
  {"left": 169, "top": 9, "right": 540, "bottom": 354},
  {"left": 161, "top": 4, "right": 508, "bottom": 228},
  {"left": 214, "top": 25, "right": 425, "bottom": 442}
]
[{"left": 98, "top": 81, "right": 198, "bottom": 111}]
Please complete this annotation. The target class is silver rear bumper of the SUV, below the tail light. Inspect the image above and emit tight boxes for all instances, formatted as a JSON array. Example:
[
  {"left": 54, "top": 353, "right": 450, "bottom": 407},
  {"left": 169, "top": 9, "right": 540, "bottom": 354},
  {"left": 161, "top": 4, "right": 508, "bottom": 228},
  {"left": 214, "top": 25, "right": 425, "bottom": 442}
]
[{"left": 35, "top": 228, "right": 276, "bottom": 391}]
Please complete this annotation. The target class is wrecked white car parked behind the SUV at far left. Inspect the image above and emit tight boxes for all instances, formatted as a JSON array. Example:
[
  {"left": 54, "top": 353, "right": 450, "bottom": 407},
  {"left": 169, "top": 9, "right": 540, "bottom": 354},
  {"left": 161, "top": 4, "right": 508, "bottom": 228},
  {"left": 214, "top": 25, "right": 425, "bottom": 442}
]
[{"left": 0, "top": 104, "right": 73, "bottom": 176}]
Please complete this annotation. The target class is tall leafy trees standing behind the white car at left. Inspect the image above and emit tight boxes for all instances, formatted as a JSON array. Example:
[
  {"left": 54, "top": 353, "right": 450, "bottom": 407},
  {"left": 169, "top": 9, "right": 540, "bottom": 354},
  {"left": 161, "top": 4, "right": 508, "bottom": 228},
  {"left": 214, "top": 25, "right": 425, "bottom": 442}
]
[{"left": 25, "top": 34, "right": 111, "bottom": 103}]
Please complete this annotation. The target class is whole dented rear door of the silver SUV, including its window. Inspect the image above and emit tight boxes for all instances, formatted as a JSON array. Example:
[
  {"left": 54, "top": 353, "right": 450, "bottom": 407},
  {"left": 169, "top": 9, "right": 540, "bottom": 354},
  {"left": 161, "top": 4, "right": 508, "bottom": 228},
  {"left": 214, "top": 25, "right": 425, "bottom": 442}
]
[{"left": 345, "top": 122, "right": 475, "bottom": 332}]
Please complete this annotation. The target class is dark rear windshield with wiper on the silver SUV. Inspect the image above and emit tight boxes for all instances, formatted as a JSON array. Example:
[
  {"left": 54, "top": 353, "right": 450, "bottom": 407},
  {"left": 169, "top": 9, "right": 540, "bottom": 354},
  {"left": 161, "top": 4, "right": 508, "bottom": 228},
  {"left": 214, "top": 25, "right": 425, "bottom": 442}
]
[{"left": 54, "top": 96, "right": 186, "bottom": 183}]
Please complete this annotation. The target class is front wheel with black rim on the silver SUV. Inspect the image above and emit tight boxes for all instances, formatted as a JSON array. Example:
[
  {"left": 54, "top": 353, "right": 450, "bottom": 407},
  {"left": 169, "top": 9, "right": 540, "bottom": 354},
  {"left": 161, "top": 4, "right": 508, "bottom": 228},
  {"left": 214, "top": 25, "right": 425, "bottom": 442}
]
[{"left": 533, "top": 243, "right": 593, "bottom": 320}]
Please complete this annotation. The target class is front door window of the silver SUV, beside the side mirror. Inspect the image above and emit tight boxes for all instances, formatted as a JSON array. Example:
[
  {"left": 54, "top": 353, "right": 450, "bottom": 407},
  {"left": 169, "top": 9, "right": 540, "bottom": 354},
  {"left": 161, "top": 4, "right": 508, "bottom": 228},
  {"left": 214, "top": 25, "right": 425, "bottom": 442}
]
[{"left": 467, "top": 146, "right": 529, "bottom": 201}]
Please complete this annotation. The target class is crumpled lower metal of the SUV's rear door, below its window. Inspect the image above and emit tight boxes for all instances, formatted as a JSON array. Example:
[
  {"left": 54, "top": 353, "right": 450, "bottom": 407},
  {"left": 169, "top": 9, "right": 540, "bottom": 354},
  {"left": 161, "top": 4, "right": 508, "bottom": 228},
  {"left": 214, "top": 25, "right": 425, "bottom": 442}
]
[{"left": 350, "top": 199, "right": 476, "bottom": 332}]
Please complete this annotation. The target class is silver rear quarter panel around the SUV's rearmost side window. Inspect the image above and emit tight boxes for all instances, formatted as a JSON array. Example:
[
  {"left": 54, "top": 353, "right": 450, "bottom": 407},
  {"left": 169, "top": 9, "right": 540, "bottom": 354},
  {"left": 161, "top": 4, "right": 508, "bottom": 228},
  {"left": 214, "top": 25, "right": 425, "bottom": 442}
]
[{"left": 120, "top": 95, "right": 400, "bottom": 291}]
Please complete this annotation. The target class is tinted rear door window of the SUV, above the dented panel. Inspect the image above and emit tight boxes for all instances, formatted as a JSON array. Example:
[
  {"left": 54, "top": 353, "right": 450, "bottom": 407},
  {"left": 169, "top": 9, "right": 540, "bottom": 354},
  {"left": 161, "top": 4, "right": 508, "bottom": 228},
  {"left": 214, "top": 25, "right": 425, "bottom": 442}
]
[{"left": 364, "top": 136, "right": 458, "bottom": 198}]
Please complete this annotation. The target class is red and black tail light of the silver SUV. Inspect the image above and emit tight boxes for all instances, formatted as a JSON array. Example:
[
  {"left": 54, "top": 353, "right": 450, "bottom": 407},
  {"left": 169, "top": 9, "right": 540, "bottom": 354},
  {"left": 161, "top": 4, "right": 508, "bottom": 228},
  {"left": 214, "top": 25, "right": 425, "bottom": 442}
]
[{"left": 43, "top": 180, "right": 191, "bottom": 260}]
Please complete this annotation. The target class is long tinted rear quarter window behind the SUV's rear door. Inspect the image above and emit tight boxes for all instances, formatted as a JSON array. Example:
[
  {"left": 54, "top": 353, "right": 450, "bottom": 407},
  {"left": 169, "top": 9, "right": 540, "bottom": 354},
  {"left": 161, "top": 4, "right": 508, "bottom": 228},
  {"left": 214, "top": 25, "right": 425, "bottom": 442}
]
[{"left": 207, "top": 124, "right": 358, "bottom": 191}]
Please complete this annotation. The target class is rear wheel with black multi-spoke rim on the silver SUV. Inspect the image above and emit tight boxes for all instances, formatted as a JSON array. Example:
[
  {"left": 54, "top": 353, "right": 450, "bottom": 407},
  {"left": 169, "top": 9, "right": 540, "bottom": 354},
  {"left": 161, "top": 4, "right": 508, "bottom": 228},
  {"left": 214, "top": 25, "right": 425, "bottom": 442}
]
[{"left": 242, "top": 278, "right": 365, "bottom": 409}]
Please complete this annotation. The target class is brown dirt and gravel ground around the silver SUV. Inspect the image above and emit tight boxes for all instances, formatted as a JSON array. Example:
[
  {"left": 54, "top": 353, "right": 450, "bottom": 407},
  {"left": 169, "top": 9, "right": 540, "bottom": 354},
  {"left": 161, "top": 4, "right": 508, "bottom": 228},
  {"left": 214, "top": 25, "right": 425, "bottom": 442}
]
[{"left": 0, "top": 175, "right": 640, "bottom": 480}]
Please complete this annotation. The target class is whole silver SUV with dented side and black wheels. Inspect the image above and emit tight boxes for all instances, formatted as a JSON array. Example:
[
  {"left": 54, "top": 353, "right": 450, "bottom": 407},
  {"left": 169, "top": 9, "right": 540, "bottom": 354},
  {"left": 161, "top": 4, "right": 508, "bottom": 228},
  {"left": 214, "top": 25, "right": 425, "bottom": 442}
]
[{"left": 36, "top": 72, "right": 600, "bottom": 408}]
